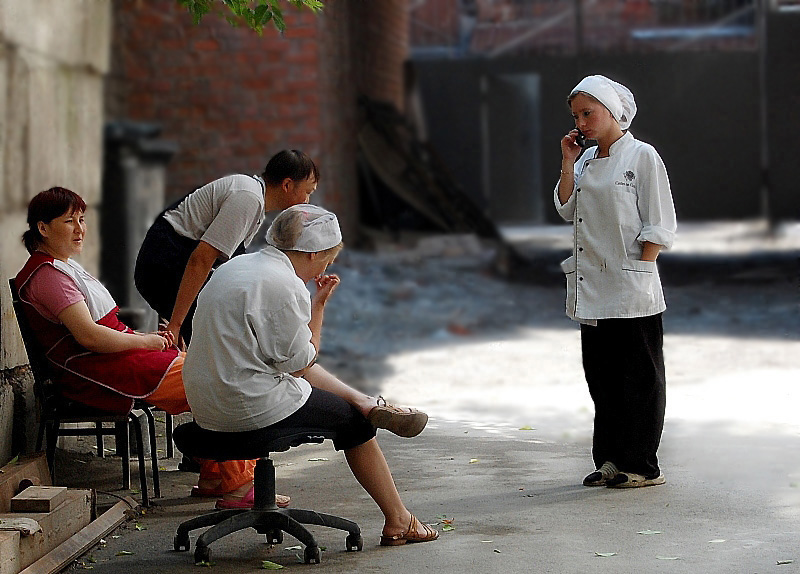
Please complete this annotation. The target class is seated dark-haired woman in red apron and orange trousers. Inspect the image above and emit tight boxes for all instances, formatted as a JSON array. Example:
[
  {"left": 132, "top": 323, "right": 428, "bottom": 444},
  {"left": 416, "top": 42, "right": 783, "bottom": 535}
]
[{"left": 14, "top": 187, "right": 288, "bottom": 505}]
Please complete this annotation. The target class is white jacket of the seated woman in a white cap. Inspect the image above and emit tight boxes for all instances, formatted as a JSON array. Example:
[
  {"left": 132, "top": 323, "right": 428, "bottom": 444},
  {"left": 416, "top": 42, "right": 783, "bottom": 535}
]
[{"left": 183, "top": 246, "right": 316, "bottom": 432}]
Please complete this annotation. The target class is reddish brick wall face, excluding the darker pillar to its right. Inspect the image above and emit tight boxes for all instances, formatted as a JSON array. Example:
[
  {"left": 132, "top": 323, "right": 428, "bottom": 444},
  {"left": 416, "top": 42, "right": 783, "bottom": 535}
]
[{"left": 107, "top": 0, "right": 321, "bottom": 205}]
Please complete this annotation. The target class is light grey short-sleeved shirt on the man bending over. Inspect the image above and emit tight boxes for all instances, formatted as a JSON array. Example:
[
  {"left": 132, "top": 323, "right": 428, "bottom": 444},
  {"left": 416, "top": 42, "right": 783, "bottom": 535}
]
[{"left": 164, "top": 174, "right": 264, "bottom": 258}]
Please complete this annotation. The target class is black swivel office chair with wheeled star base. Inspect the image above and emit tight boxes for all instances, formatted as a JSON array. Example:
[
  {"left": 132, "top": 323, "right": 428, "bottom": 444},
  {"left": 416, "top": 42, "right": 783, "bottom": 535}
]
[{"left": 173, "top": 422, "right": 364, "bottom": 564}]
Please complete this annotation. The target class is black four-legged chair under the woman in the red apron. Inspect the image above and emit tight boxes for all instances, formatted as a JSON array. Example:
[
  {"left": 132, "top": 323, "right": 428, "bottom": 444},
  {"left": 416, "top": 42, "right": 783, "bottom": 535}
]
[{"left": 8, "top": 279, "right": 167, "bottom": 507}]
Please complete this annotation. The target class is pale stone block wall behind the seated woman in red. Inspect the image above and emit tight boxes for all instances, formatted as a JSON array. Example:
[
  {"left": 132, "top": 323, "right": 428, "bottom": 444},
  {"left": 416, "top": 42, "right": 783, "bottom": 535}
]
[{"left": 0, "top": 0, "right": 111, "bottom": 464}]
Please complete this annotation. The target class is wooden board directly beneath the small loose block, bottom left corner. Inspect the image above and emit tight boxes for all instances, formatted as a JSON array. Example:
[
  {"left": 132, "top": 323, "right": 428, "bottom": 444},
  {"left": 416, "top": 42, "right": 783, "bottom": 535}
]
[{"left": 0, "top": 490, "right": 92, "bottom": 568}]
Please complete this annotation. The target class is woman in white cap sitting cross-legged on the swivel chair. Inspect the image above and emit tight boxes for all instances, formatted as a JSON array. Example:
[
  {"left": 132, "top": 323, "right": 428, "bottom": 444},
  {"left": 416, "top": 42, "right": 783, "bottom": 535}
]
[{"left": 184, "top": 204, "right": 438, "bottom": 546}]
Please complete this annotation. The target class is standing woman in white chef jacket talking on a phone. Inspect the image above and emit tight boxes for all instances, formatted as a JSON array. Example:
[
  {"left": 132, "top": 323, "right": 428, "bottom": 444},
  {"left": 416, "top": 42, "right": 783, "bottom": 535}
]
[{"left": 554, "top": 75, "right": 676, "bottom": 488}]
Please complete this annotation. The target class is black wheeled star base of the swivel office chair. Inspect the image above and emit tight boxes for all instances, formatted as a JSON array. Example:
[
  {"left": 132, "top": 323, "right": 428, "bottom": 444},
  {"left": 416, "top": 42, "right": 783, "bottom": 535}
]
[{"left": 174, "top": 508, "right": 364, "bottom": 564}]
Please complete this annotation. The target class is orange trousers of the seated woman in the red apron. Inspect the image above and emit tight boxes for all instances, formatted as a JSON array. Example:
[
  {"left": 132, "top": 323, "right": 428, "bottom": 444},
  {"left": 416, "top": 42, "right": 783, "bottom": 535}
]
[{"left": 145, "top": 353, "right": 256, "bottom": 496}]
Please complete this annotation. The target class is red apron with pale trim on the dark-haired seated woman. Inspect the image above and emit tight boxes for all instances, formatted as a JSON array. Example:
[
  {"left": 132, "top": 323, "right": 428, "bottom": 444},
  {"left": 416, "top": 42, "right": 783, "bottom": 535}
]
[{"left": 14, "top": 252, "right": 178, "bottom": 413}]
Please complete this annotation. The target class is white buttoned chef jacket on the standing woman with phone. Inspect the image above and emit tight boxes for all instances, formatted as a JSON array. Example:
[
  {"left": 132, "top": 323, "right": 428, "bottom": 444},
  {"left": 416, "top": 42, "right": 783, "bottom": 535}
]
[{"left": 555, "top": 132, "right": 677, "bottom": 324}]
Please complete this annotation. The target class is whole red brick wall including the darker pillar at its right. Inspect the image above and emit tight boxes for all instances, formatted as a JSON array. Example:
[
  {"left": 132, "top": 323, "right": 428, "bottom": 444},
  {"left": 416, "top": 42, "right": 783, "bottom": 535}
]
[{"left": 107, "top": 0, "right": 408, "bottom": 239}]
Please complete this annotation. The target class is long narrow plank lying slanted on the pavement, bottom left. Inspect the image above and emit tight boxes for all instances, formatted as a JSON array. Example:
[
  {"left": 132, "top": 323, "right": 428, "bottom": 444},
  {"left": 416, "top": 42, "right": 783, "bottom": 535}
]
[{"left": 19, "top": 496, "right": 138, "bottom": 574}]
